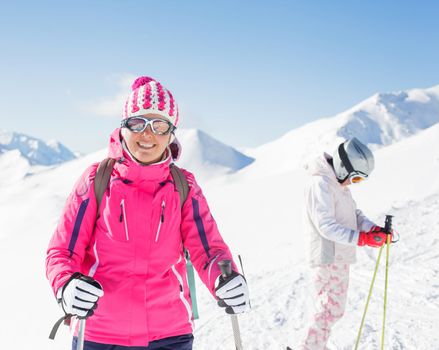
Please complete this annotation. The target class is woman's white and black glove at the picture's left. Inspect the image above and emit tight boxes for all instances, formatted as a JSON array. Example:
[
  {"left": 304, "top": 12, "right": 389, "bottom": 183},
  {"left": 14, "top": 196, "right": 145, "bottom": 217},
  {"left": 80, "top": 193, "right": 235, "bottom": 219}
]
[{"left": 61, "top": 273, "right": 104, "bottom": 318}]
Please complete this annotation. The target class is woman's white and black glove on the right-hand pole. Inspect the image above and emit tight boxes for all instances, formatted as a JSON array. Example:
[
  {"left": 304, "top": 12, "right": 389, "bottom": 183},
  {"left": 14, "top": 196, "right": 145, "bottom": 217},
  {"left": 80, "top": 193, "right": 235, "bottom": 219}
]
[{"left": 215, "top": 271, "right": 250, "bottom": 314}]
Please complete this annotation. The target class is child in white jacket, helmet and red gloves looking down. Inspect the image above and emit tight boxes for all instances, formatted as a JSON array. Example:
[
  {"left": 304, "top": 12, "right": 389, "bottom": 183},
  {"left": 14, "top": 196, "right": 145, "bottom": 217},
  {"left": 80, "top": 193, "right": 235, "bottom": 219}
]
[{"left": 302, "top": 138, "right": 392, "bottom": 350}]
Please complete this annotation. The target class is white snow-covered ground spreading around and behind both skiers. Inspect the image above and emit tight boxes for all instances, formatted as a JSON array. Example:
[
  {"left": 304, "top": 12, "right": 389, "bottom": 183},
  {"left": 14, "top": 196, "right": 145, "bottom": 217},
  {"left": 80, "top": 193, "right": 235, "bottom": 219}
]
[{"left": 0, "top": 85, "right": 439, "bottom": 350}]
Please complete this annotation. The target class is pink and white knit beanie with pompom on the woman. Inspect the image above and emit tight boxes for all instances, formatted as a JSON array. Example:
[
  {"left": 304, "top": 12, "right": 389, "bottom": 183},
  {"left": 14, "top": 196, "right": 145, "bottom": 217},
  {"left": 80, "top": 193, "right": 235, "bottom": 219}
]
[{"left": 123, "top": 77, "right": 179, "bottom": 126}]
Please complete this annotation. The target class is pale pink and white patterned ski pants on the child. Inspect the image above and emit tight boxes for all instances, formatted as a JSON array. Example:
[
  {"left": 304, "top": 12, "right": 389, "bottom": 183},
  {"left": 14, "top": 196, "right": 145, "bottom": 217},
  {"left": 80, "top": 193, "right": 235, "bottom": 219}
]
[{"left": 302, "top": 264, "right": 349, "bottom": 350}]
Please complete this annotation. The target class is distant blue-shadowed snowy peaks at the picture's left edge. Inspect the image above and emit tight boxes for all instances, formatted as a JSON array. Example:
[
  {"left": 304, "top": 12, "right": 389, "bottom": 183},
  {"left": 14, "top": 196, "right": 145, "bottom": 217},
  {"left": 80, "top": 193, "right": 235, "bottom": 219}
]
[{"left": 0, "top": 130, "right": 76, "bottom": 165}]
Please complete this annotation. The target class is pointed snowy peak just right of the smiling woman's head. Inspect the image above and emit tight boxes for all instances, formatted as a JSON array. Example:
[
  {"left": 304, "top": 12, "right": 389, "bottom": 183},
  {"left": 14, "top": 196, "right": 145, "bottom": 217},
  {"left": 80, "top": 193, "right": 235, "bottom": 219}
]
[{"left": 177, "top": 129, "right": 254, "bottom": 172}]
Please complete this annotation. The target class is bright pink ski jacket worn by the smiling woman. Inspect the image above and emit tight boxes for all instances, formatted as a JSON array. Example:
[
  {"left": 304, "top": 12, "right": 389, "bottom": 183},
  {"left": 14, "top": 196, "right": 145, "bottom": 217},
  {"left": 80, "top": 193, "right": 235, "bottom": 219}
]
[{"left": 46, "top": 129, "right": 236, "bottom": 346}]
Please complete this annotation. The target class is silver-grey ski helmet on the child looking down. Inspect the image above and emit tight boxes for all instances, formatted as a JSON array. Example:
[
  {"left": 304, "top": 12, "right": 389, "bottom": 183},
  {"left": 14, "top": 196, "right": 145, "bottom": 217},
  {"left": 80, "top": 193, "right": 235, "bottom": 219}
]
[{"left": 332, "top": 137, "right": 375, "bottom": 182}]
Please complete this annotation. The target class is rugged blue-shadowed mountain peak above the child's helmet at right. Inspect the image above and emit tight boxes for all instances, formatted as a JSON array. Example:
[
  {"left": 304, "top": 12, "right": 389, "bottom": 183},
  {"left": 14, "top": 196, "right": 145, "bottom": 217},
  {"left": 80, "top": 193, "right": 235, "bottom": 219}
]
[{"left": 335, "top": 85, "right": 439, "bottom": 146}]
